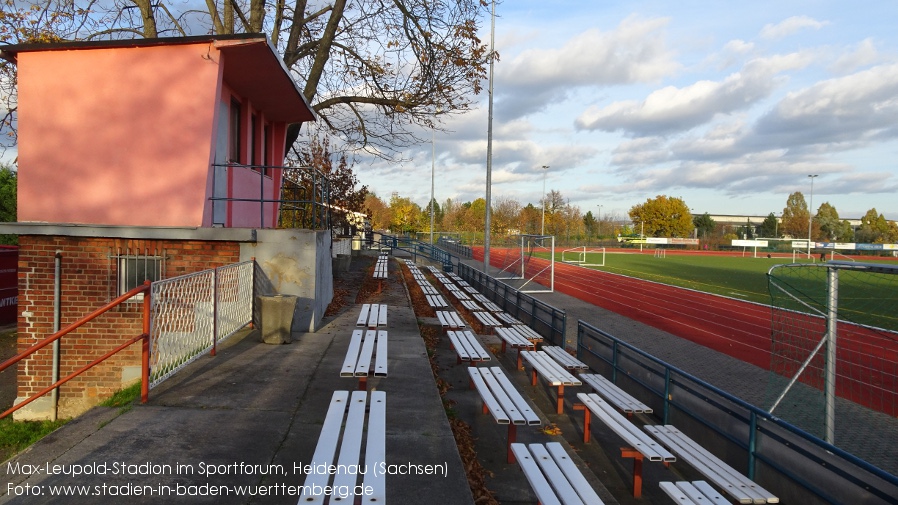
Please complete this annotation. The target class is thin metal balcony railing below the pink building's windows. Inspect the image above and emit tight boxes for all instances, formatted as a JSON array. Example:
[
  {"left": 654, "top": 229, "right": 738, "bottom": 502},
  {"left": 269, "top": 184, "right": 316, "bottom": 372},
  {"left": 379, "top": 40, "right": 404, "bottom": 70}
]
[{"left": 209, "top": 163, "right": 333, "bottom": 230}]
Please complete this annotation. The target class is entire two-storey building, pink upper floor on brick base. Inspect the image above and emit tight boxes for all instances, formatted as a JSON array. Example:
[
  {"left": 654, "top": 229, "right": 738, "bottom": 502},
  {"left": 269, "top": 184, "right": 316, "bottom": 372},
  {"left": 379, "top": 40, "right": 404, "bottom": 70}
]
[{"left": 0, "top": 34, "right": 333, "bottom": 419}]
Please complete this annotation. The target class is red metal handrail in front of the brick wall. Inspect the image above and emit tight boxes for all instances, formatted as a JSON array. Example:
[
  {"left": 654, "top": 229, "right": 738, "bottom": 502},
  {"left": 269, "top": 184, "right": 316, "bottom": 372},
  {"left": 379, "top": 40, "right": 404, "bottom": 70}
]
[{"left": 0, "top": 281, "right": 151, "bottom": 419}]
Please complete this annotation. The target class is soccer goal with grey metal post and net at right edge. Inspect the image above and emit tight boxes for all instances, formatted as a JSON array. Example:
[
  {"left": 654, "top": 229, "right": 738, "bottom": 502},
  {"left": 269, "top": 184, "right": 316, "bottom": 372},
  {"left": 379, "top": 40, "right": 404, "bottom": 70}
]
[{"left": 767, "top": 261, "right": 898, "bottom": 451}]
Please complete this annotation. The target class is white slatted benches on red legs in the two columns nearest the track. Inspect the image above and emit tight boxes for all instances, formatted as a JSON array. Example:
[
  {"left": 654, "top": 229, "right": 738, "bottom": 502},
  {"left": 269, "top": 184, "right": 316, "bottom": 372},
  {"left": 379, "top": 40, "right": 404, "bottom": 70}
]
[{"left": 416, "top": 258, "right": 778, "bottom": 504}]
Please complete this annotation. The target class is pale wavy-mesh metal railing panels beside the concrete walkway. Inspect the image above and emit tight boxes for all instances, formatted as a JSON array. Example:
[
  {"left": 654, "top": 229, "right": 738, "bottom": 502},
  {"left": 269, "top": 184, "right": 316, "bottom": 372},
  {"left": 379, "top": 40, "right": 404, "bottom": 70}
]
[{"left": 150, "top": 260, "right": 255, "bottom": 388}]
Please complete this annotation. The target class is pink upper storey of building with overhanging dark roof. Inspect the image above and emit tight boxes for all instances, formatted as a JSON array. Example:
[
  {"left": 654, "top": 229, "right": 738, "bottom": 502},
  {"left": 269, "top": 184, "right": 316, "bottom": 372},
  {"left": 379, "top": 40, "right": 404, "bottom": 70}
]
[{"left": 2, "top": 34, "right": 314, "bottom": 228}]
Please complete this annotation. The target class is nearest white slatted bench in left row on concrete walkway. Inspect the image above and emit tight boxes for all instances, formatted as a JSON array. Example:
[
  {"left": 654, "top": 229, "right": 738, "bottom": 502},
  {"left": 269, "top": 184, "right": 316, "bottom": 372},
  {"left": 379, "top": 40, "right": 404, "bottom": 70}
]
[{"left": 298, "top": 391, "right": 387, "bottom": 505}]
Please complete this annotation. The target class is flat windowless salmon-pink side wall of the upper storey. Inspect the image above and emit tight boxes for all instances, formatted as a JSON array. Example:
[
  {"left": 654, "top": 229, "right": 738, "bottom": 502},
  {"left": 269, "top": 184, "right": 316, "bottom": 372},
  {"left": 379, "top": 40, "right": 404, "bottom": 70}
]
[{"left": 18, "top": 43, "right": 220, "bottom": 226}]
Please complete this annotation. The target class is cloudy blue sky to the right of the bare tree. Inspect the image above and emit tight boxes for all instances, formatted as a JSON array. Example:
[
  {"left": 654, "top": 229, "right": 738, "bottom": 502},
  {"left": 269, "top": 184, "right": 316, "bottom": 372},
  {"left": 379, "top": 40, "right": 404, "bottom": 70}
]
[{"left": 356, "top": 0, "right": 898, "bottom": 220}]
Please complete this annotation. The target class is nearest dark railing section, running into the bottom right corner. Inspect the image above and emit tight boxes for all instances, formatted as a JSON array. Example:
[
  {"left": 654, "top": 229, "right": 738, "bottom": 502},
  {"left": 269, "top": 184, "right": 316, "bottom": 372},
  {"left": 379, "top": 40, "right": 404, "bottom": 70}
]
[{"left": 577, "top": 321, "right": 898, "bottom": 504}]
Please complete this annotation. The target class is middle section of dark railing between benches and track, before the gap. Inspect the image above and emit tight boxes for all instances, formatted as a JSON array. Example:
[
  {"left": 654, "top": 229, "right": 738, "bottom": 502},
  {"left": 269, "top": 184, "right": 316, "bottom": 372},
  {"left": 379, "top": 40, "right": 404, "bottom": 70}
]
[{"left": 458, "top": 263, "right": 567, "bottom": 347}]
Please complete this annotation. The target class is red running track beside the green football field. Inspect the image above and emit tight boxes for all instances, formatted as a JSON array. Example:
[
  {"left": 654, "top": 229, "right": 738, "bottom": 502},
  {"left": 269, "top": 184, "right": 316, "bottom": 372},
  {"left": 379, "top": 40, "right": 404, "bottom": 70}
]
[{"left": 474, "top": 248, "right": 898, "bottom": 415}]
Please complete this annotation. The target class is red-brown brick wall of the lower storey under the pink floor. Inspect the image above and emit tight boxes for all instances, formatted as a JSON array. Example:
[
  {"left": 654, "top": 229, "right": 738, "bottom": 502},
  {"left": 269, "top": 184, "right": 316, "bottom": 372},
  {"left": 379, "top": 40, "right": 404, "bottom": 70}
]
[{"left": 18, "top": 235, "right": 240, "bottom": 418}]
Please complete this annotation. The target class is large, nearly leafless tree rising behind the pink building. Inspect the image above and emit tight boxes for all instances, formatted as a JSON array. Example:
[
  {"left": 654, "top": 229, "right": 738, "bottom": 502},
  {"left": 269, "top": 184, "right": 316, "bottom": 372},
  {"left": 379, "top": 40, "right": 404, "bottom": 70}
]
[{"left": 0, "top": 0, "right": 491, "bottom": 158}]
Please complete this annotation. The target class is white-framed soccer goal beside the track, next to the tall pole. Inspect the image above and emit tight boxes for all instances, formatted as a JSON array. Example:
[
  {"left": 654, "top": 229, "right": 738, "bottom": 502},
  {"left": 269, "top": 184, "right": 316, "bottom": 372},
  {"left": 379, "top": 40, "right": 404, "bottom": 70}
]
[{"left": 496, "top": 235, "right": 555, "bottom": 293}]
